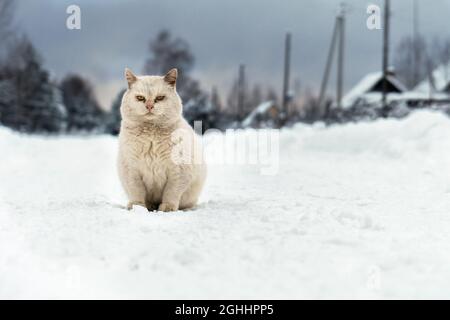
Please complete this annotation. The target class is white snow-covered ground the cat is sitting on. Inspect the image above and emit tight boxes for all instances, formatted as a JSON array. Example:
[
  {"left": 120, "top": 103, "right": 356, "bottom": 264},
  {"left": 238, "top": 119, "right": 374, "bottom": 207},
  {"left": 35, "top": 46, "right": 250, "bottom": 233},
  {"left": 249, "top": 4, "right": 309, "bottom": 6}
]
[{"left": 0, "top": 112, "right": 450, "bottom": 299}]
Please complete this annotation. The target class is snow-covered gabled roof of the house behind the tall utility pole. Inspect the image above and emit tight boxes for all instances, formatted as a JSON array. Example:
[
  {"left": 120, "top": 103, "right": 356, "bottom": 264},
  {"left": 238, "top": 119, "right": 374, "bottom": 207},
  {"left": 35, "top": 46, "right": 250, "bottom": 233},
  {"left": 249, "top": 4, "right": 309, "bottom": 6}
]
[{"left": 342, "top": 71, "right": 407, "bottom": 109}]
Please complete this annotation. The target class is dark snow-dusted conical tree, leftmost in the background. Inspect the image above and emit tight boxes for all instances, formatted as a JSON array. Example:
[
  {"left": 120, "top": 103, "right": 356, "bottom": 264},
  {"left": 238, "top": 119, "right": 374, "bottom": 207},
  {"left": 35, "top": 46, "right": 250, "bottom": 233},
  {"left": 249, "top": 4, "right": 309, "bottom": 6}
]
[{"left": 0, "top": 37, "right": 66, "bottom": 132}]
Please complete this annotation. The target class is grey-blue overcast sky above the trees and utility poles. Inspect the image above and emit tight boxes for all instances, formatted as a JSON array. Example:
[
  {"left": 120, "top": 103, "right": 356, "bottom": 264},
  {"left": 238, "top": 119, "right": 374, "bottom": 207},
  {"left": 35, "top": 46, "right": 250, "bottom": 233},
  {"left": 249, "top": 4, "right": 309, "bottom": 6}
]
[{"left": 12, "top": 0, "right": 450, "bottom": 106}]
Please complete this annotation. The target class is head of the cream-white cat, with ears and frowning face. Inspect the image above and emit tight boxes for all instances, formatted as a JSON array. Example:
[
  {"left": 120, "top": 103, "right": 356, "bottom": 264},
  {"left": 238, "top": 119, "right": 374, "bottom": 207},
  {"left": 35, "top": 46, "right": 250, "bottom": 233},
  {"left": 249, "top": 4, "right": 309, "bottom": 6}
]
[{"left": 120, "top": 69, "right": 182, "bottom": 126}]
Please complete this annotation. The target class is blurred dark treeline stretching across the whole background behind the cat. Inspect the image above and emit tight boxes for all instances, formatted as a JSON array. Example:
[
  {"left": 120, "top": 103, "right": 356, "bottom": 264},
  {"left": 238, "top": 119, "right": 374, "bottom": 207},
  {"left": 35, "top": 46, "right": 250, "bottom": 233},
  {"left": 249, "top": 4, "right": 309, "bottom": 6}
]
[{"left": 0, "top": 0, "right": 450, "bottom": 135}]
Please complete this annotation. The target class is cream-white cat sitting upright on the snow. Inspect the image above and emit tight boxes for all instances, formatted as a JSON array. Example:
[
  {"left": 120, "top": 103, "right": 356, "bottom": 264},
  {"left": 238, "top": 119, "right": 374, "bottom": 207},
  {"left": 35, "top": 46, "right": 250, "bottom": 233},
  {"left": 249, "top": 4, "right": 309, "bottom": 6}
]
[{"left": 118, "top": 69, "right": 206, "bottom": 211}]
